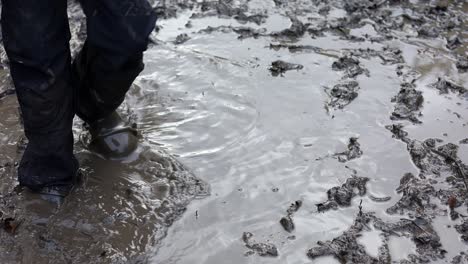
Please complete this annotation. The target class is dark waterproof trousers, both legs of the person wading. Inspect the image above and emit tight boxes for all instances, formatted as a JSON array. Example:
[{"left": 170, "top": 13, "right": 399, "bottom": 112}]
[{"left": 1, "top": 0, "right": 156, "bottom": 190}]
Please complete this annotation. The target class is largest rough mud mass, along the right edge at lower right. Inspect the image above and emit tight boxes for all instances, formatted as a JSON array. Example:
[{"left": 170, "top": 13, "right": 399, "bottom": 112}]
[{"left": 387, "top": 125, "right": 468, "bottom": 258}]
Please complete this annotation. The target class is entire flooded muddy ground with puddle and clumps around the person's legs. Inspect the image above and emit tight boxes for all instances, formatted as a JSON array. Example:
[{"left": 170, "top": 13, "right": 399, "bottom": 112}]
[{"left": 0, "top": 0, "right": 468, "bottom": 264}]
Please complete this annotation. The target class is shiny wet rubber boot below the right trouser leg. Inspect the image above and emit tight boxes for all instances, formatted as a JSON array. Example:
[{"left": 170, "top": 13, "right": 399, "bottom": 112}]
[{"left": 88, "top": 111, "right": 138, "bottom": 159}]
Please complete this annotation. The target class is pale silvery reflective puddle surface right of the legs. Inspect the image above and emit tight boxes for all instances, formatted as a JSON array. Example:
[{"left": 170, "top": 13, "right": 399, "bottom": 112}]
[{"left": 143, "top": 1, "right": 468, "bottom": 264}]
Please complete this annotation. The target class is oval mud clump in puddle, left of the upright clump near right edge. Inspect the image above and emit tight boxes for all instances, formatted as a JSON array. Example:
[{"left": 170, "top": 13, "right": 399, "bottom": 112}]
[{"left": 325, "top": 81, "right": 360, "bottom": 109}]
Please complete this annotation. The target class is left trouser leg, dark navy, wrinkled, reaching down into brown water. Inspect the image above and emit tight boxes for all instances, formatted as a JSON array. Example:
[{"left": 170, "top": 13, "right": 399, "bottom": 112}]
[{"left": 2, "top": 0, "right": 78, "bottom": 189}]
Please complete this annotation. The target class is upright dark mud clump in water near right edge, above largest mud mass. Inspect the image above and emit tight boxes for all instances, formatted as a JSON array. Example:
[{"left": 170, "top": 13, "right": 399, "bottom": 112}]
[{"left": 391, "top": 83, "right": 424, "bottom": 123}]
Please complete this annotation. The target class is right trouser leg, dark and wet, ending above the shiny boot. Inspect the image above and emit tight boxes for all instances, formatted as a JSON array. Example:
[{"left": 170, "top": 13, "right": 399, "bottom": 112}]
[{"left": 73, "top": 0, "right": 156, "bottom": 123}]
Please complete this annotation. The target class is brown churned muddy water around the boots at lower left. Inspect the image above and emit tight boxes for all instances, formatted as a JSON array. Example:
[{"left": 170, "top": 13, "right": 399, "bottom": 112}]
[{"left": 0, "top": 93, "right": 208, "bottom": 263}]
